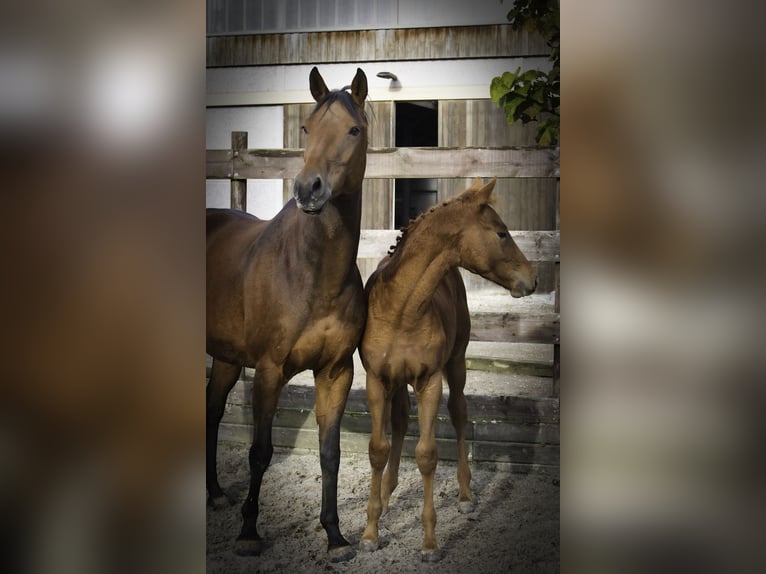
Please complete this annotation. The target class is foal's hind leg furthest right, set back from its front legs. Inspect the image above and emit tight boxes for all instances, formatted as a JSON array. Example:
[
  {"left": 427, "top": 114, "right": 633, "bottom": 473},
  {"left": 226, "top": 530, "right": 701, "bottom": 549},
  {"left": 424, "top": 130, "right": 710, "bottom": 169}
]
[{"left": 445, "top": 354, "right": 474, "bottom": 513}]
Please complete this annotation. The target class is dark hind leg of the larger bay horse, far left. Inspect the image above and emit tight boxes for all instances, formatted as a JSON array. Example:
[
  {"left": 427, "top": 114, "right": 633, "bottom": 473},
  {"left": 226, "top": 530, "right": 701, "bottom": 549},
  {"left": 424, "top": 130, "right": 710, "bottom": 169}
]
[{"left": 205, "top": 359, "right": 242, "bottom": 508}]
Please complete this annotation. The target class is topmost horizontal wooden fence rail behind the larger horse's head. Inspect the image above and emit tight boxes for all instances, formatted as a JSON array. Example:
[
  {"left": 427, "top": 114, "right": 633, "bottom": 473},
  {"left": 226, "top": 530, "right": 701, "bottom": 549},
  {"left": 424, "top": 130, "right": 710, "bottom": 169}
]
[{"left": 213, "top": 147, "right": 559, "bottom": 179}]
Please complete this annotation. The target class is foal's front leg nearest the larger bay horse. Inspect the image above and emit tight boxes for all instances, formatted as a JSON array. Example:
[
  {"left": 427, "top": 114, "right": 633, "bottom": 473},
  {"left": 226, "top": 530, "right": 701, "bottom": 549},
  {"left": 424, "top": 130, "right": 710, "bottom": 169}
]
[{"left": 359, "top": 371, "right": 391, "bottom": 552}]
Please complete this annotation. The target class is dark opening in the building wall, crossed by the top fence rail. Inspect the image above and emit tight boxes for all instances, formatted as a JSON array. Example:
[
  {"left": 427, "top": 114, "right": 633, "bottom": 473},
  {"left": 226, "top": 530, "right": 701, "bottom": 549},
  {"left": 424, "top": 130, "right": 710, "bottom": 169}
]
[{"left": 394, "top": 101, "right": 439, "bottom": 229}]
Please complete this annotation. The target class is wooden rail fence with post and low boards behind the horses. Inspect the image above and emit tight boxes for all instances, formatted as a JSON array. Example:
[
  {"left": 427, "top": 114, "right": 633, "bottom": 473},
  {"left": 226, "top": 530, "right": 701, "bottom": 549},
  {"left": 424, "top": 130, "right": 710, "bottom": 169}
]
[{"left": 206, "top": 132, "right": 560, "bottom": 467}]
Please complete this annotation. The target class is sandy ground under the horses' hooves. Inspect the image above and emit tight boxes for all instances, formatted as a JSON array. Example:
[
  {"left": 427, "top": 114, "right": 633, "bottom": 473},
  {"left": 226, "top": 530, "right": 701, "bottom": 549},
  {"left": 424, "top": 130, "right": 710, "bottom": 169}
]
[{"left": 207, "top": 444, "right": 559, "bottom": 574}]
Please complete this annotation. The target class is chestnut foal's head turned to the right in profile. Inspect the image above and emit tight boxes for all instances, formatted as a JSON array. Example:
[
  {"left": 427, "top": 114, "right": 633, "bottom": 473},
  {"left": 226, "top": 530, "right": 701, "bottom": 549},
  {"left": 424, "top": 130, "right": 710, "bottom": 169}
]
[{"left": 459, "top": 178, "right": 537, "bottom": 297}]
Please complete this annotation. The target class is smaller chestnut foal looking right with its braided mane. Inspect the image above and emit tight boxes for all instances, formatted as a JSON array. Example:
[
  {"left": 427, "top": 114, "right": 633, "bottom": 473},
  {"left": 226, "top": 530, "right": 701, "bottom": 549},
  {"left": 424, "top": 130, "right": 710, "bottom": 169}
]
[{"left": 360, "top": 178, "right": 537, "bottom": 561}]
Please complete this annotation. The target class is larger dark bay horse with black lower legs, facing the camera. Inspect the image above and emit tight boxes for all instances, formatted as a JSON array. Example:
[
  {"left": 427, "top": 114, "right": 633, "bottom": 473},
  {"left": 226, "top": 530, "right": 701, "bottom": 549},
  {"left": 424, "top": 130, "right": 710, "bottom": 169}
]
[{"left": 207, "top": 68, "right": 367, "bottom": 561}]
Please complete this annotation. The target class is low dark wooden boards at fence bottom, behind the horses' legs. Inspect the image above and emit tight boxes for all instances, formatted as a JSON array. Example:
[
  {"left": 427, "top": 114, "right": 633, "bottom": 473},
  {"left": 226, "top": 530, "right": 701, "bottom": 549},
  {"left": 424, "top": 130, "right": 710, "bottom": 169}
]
[{"left": 219, "top": 374, "right": 560, "bottom": 473}]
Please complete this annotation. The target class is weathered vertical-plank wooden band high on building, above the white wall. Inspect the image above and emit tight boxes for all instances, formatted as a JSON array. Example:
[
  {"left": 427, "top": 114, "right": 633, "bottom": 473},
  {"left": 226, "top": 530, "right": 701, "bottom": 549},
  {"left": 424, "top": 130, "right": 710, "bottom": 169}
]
[{"left": 207, "top": 24, "right": 550, "bottom": 68}]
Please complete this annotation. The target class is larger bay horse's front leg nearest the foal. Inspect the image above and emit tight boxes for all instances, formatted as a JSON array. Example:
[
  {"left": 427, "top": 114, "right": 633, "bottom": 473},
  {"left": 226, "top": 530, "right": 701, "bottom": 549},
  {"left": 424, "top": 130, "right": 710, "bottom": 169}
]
[{"left": 314, "top": 356, "right": 355, "bottom": 562}]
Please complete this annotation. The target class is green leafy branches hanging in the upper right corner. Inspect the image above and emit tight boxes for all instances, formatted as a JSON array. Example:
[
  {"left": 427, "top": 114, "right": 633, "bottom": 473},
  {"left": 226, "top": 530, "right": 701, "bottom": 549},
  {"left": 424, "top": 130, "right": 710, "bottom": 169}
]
[{"left": 496, "top": 0, "right": 561, "bottom": 145}]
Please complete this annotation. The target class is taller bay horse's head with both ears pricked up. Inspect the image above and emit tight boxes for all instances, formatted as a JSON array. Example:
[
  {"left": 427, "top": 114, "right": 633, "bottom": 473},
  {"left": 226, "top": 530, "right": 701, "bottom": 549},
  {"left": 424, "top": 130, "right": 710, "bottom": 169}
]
[{"left": 293, "top": 67, "right": 367, "bottom": 215}]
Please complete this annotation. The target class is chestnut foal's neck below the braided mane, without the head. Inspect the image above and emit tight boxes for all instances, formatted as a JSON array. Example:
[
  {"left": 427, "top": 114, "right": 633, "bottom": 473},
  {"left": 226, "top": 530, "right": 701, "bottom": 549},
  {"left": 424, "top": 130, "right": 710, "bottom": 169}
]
[{"left": 382, "top": 214, "right": 460, "bottom": 320}]
